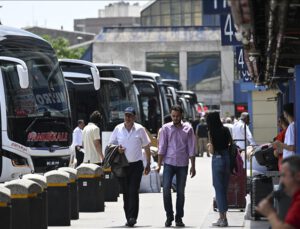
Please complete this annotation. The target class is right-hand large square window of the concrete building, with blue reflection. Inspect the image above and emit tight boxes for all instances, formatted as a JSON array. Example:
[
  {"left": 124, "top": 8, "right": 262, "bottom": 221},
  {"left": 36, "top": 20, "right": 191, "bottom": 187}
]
[{"left": 187, "top": 52, "right": 221, "bottom": 91}]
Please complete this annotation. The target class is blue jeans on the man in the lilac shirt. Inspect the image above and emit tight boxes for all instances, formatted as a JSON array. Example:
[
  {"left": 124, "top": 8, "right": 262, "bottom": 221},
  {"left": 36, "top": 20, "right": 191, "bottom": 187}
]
[{"left": 163, "top": 164, "right": 188, "bottom": 220}]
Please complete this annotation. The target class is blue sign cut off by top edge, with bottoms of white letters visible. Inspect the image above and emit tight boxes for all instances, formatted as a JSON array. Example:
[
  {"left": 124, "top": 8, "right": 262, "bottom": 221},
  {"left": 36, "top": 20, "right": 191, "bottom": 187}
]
[{"left": 202, "top": 0, "right": 230, "bottom": 14}]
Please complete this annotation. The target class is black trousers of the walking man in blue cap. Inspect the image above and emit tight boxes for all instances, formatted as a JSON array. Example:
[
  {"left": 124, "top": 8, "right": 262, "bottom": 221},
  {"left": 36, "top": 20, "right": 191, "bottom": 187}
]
[{"left": 118, "top": 161, "right": 144, "bottom": 221}]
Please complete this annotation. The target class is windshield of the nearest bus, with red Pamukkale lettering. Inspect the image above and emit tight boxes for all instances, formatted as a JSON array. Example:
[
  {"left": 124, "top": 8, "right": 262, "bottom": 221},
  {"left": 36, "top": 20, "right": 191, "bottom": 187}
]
[{"left": 1, "top": 48, "right": 71, "bottom": 147}]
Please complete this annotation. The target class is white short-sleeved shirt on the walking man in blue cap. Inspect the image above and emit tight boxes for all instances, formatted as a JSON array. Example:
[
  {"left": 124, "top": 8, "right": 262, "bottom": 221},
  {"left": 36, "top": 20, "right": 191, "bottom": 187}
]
[{"left": 109, "top": 123, "right": 150, "bottom": 162}]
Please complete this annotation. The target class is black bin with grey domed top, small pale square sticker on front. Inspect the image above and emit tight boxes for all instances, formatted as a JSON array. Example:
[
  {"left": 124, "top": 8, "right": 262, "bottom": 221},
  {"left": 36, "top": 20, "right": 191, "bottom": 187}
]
[{"left": 77, "top": 163, "right": 104, "bottom": 212}]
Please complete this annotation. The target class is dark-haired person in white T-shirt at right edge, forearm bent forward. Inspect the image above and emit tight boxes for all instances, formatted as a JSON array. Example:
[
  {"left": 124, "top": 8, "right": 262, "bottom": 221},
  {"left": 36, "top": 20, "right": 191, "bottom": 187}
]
[{"left": 273, "top": 103, "right": 296, "bottom": 158}]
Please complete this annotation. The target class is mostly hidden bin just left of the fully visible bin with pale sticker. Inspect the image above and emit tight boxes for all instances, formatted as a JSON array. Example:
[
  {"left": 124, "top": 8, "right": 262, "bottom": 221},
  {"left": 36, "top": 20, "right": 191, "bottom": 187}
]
[{"left": 58, "top": 167, "right": 79, "bottom": 219}]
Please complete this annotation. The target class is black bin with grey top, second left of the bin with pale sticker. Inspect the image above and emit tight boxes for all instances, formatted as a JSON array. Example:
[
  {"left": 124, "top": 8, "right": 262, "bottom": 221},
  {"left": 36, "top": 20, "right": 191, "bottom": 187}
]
[{"left": 44, "top": 170, "right": 71, "bottom": 226}]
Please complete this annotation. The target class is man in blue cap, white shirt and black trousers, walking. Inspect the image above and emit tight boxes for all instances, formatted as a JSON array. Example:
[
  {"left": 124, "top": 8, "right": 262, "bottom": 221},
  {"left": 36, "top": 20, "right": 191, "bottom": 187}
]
[{"left": 109, "top": 107, "right": 151, "bottom": 227}]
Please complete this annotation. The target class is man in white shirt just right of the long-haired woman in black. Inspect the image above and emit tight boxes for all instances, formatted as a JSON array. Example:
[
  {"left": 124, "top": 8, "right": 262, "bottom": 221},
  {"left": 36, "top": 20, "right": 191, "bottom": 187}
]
[{"left": 232, "top": 112, "right": 256, "bottom": 150}]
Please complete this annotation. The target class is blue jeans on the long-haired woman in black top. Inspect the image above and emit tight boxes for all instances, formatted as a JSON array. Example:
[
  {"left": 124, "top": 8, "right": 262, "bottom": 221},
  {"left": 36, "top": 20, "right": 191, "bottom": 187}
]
[{"left": 211, "top": 150, "right": 230, "bottom": 213}]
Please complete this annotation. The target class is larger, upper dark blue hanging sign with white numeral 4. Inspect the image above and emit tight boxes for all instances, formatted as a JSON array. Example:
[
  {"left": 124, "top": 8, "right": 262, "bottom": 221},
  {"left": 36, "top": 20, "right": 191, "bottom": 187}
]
[{"left": 220, "top": 14, "right": 241, "bottom": 46}]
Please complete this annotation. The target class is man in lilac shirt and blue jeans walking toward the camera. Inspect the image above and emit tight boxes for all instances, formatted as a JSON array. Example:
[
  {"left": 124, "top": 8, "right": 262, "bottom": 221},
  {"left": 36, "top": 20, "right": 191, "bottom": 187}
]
[{"left": 158, "top": 105, "right": 196, "bottom": 227}]
